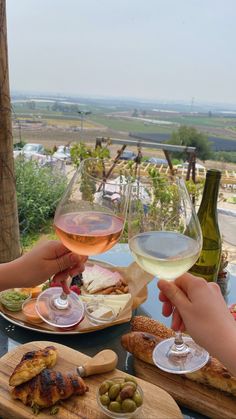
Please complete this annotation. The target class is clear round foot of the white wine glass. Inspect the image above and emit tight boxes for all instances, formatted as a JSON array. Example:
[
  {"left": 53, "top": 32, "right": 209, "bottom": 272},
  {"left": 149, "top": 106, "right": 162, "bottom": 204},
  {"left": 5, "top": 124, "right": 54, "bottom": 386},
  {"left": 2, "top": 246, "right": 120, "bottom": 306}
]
[{"left": 152, "top": 336, "right": 209, "bottom": 374}]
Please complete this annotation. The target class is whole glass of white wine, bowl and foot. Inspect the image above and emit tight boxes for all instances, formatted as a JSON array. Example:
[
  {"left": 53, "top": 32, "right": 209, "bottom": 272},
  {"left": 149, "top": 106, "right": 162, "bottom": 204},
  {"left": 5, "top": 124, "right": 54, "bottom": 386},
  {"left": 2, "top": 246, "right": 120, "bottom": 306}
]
[{"left": 128, "top": 172, "right": 209, "bottom": 374}]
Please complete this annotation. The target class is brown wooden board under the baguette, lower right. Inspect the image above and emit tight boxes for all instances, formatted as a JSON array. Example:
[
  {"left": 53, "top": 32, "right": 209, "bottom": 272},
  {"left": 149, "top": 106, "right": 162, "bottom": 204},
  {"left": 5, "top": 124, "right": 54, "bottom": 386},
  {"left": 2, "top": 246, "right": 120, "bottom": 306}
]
[{"left": 134, "top": 358, "right": 236, "bottom": 419}]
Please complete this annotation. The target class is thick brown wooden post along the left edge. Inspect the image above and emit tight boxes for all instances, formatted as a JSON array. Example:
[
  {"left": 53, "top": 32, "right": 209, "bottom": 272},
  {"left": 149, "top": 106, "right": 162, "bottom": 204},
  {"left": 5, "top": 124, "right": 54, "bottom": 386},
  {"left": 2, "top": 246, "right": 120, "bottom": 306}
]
[{"left": 0, "top": 0, "right": 20, "bottom": 263}]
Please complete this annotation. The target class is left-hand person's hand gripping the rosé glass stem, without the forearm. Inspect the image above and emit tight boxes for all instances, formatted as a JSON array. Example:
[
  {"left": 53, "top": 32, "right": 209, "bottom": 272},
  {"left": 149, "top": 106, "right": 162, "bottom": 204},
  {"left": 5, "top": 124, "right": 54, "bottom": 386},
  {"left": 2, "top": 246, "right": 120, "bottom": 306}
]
[{"left": 20, "top": 240, "right": 87, "bottom": 293}]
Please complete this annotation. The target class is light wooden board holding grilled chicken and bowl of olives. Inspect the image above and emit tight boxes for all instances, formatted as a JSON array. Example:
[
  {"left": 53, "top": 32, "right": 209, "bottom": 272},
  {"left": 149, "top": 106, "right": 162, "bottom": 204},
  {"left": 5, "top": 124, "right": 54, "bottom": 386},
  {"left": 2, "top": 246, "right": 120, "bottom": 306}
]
[{"left": 0, "top": 341, "right": 182, "bottom": 419}]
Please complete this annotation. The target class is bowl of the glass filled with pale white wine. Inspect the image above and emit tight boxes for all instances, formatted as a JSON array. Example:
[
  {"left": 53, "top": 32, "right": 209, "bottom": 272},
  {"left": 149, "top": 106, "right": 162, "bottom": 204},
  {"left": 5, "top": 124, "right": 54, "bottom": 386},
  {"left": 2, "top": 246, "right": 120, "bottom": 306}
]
[{"left": 129, "top": 178, "right": 202, "bottom": 280}]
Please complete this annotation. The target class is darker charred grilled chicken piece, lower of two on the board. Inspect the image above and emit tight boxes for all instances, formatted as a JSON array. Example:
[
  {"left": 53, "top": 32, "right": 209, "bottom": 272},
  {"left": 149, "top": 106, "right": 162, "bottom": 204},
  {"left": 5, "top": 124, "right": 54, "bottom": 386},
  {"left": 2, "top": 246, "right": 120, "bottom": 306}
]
[{"left": 12, "top": 369, "right": 88, "bottom": 408}]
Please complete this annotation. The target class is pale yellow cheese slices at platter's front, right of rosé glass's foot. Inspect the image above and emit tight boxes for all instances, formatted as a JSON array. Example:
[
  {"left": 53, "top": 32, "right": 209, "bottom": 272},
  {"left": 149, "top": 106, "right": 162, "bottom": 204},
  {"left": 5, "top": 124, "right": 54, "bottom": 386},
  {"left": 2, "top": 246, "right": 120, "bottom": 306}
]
[{"left": 80, "top": 293, "right": 131, "bottom": 316}]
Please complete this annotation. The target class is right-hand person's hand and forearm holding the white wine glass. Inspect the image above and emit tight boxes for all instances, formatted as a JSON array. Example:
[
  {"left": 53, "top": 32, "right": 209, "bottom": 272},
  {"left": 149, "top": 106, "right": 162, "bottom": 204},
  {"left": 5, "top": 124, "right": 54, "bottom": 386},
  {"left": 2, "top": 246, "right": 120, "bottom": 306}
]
[{"left": 158, "top": 273, "right": 236, "bottom": 376}]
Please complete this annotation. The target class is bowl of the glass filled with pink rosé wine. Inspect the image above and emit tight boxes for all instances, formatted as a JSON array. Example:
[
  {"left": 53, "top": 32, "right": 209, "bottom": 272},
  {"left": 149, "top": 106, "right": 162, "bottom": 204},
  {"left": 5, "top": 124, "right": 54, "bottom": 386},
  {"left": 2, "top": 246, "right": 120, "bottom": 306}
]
[{"left": 54, "top": 158, "right": 128, "bottom": 256}]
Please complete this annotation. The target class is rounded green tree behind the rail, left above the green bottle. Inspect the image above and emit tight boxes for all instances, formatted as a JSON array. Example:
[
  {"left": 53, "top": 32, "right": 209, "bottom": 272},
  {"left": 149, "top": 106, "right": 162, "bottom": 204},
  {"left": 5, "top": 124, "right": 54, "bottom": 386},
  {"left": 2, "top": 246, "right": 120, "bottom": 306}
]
[{"left": 168, "top": 125, "right": 212, "bottom": 161}]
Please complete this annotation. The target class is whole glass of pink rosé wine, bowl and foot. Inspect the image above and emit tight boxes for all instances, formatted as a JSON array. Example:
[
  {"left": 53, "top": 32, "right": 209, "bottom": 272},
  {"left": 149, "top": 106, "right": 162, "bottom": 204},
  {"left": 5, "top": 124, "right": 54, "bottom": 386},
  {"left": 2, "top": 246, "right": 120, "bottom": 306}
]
[{"left": 36, "top": 158, "right": 129, "bottom": 328}]
